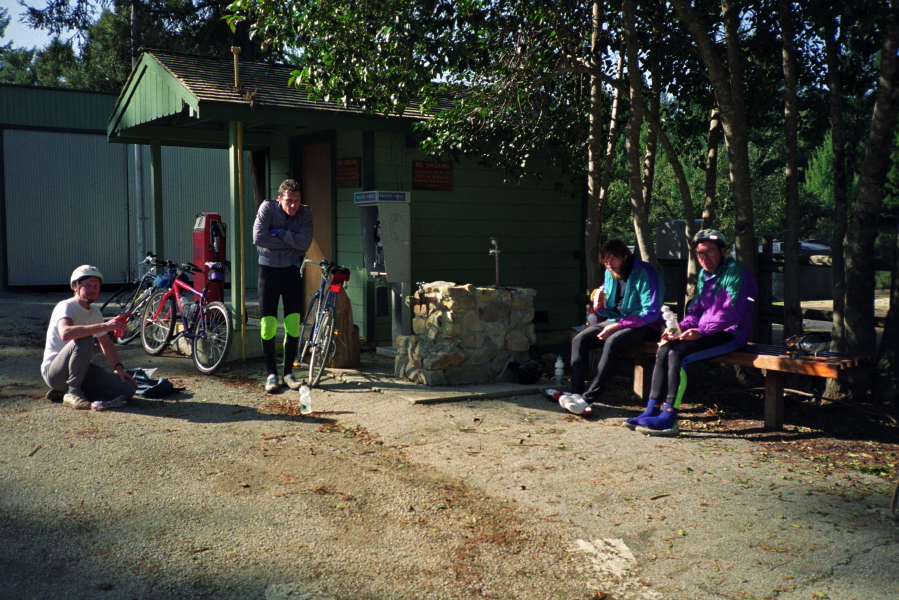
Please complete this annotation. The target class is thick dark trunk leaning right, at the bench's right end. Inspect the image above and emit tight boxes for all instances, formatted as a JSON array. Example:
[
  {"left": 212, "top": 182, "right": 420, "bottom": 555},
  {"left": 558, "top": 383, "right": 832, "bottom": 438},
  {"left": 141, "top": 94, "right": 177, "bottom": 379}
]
[{"left": 845, "top": 7, "right": 899, "bottom": 400}]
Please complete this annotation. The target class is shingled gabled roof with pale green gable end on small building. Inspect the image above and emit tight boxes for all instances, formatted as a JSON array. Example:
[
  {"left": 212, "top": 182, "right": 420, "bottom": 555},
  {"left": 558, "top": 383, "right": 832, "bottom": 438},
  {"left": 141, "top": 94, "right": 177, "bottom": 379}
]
[{"left": 107, "top": 50, "right": 422, "bottom": 146}]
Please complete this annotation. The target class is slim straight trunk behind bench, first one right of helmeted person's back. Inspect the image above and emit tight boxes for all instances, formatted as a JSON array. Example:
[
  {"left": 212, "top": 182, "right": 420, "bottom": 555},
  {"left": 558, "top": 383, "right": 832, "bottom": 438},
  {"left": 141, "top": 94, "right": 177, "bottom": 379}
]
[{"left": 777, "top": 0, "right": 802, "bottom": 337}]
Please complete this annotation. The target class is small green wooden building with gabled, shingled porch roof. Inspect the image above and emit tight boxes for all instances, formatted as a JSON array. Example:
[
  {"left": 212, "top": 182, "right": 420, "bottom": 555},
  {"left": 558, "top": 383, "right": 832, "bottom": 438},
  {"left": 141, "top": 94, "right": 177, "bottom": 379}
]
[{"left": 107, "top": 50, "right": 584, "bottom": 345}]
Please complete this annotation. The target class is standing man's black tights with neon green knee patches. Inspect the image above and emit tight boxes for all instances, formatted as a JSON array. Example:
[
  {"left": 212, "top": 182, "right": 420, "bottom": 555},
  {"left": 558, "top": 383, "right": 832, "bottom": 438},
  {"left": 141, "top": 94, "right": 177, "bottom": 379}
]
[{"left": 259, "top": 265, "right": 303, "bottom": 375}]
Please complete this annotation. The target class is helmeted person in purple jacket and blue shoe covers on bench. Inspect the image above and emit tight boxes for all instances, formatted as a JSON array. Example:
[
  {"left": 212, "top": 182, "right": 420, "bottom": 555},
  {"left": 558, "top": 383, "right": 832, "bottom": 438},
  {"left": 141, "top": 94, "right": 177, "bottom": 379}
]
[{"left": 624, "top": 229, "right": 758, "bottom": 436}]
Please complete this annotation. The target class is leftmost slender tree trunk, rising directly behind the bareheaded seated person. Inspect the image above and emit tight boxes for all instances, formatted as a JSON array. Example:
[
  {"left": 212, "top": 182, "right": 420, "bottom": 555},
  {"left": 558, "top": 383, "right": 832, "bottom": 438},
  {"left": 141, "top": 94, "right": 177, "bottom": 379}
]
[{"left": 584, "top": 0, "right": 605, "bottom": 290}]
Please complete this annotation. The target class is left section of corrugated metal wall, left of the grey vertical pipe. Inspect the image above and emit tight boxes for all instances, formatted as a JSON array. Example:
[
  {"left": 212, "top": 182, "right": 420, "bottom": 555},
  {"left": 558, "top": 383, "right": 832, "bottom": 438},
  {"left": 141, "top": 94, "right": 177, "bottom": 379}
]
[{"left": 3, "top": 130, "right": 130, "bottom": 285}]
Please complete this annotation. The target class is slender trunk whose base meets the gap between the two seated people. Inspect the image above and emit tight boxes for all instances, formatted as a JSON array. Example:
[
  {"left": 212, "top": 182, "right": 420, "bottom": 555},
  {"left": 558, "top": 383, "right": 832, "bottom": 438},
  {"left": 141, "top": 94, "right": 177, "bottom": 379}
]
[{"left": 622, "top": 0, "right": 658, "bottom": 264}]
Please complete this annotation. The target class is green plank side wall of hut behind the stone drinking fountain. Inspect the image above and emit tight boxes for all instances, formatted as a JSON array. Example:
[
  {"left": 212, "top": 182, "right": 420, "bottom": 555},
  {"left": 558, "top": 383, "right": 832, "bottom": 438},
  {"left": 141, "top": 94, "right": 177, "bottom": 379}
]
[{"left": 337, "top": 131, "right": 583, "bottom": 342}]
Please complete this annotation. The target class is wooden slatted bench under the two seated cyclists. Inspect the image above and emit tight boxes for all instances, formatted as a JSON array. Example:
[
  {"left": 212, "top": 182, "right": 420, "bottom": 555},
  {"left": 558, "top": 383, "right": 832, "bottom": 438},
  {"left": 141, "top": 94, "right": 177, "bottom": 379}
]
[{"left": 625, "top": 342, "right": 869, "bottom": 429}]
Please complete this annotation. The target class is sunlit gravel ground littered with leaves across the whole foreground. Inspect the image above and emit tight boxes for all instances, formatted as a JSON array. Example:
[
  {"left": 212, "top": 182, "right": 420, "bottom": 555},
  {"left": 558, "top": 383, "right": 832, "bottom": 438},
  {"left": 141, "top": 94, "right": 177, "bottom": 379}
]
[{"left": 0, "top": 292, "right": 899, "bottom": 600}]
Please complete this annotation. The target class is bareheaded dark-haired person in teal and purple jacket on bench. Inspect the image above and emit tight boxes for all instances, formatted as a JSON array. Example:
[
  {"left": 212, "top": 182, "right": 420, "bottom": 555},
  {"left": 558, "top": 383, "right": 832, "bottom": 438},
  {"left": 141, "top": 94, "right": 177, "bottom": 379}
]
[{"left": 571, "top": 240, "right": 665, "bottom": 403}]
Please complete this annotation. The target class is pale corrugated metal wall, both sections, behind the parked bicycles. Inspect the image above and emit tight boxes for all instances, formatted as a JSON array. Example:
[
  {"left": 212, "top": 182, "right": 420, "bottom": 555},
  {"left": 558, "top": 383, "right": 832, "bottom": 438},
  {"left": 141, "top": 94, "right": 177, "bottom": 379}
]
[{"left": 3, "top": 129, "right": 236, "bottom": 286}]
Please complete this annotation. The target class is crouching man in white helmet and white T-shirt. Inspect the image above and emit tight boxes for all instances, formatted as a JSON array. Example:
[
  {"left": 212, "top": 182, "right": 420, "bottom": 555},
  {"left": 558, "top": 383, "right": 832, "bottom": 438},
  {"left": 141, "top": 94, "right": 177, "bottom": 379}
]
[{"left": 41, "top": 265, "right": 137, "bottom": 410}]
